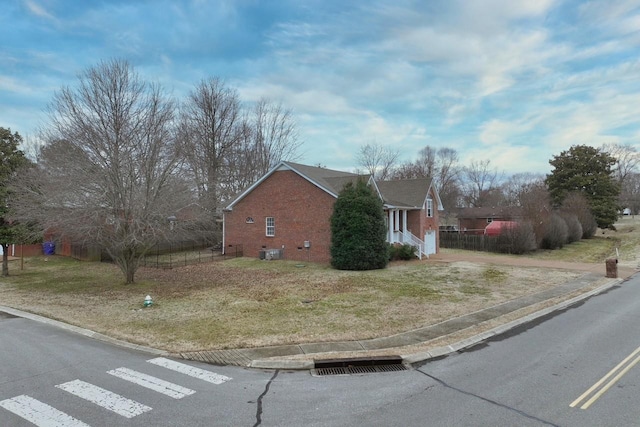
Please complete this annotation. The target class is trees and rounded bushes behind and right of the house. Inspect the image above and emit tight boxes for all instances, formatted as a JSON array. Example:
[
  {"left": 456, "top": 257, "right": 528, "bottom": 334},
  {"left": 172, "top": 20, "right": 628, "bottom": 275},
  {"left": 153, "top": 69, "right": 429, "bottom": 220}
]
[{"left": 357, "top": 144, "right": 640, "bottom": 252}]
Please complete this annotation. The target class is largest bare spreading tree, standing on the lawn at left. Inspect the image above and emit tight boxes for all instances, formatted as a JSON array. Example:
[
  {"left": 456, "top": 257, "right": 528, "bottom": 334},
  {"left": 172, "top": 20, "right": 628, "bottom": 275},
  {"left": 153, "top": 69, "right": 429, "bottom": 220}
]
[{"left": 16, "top": 60, "right": 185, "bottom": 283}]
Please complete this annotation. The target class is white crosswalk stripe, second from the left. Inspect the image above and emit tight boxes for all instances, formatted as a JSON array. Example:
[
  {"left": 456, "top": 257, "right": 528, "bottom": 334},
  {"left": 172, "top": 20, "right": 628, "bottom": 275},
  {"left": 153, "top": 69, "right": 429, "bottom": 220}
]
[{"left": 56, "top": 380, "right": 152, "bottom": 418}]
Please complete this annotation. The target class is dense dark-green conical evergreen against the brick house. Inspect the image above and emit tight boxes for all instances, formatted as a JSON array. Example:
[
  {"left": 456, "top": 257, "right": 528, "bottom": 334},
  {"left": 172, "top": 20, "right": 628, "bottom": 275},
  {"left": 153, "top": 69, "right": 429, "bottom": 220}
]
[{"left": 331, "top": 180, "right": 389, "bottom": 270}]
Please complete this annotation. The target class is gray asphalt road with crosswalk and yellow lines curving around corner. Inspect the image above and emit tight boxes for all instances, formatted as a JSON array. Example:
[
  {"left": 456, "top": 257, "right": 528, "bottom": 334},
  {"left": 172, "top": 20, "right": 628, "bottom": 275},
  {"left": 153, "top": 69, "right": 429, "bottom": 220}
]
[{"left": 0, "top": 277, "right": 640, "bottom": 427}]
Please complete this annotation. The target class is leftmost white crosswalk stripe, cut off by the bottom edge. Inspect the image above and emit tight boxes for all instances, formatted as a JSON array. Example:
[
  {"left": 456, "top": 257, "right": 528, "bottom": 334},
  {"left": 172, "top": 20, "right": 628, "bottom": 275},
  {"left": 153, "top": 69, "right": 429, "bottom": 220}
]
[{"left": 0, "top": 394, "right": 89, "bottom": 427}]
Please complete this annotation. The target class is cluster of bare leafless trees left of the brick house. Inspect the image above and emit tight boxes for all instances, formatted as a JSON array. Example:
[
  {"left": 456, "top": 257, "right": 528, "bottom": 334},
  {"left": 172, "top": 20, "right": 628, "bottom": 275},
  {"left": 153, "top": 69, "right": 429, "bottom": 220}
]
[{"left": 4, "top": 59, "right": 301, "bottom": 283}]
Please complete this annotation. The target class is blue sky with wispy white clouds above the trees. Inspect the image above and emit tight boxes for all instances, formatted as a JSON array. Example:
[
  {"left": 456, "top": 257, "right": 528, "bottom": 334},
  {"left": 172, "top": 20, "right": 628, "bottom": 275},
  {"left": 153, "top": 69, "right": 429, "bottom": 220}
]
[{"left": 0, "top": 0, "right": 640, "bottom": 175}]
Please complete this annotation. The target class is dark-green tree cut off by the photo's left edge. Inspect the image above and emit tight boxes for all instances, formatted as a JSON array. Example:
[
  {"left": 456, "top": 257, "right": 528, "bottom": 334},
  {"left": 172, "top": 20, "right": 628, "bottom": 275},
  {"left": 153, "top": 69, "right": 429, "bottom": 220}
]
[{"left": 0, "top": 127, "right": 30, "bottom": 276}]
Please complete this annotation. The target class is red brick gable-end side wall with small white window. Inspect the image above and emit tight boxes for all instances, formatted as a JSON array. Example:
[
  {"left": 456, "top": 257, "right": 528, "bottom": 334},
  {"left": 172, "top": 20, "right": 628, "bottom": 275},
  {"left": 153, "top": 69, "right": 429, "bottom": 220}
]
[{"left": 225, "top": 171, "right": 336, "bottom": 263}]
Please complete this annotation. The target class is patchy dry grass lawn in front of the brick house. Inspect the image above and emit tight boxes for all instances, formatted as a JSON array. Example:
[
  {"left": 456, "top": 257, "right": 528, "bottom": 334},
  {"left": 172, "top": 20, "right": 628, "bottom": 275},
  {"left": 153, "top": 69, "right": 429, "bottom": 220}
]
[{"left": 0, "top": 257, "right": 579, "bottom": 351}]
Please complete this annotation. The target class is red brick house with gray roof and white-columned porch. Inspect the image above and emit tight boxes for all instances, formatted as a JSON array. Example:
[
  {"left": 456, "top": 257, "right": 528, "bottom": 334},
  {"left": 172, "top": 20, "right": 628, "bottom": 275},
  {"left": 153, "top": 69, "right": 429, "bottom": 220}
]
[{"left": 222, "top": 162, "right": 442, "bottom": 263}]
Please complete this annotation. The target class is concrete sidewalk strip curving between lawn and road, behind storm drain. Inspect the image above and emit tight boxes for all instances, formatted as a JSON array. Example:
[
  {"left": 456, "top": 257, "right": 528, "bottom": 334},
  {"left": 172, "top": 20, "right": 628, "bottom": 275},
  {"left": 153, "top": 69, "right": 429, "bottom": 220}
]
[{"left": 175, "top": 274, "right": 631, "bottom": 369}]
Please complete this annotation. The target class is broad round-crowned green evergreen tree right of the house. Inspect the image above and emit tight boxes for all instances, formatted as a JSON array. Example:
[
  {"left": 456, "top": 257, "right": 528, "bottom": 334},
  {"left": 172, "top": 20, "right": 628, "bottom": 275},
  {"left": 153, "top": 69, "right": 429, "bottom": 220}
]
[{"left": 545, "top": 145, "right": 620, "bottom": 228}]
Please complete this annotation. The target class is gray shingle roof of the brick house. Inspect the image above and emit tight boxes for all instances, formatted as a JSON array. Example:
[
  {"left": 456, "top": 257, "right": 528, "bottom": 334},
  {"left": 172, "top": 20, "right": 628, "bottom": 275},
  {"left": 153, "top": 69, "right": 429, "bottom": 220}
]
[{"left": 226, "top": 161, "right": 442, "bottom": 210}]
